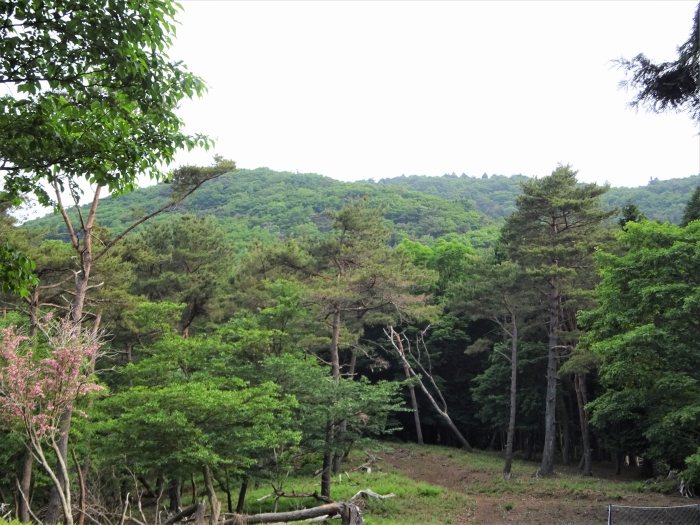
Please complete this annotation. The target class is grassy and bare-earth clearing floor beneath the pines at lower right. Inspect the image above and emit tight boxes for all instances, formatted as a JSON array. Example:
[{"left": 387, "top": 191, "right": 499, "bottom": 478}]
[{"left": 368, "top": 445, "right": 698, "bottom": 525}]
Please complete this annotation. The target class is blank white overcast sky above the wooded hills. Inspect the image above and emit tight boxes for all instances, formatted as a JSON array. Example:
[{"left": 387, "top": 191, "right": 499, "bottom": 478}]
[{"left": 170, "top": 0, "right": 700, "bottom": 186}]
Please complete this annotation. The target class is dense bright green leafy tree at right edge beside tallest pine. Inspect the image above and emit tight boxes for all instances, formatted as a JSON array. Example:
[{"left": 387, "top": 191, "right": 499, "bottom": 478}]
[{"left": 581, "top": 221, "right": 700, "bottom": 468}]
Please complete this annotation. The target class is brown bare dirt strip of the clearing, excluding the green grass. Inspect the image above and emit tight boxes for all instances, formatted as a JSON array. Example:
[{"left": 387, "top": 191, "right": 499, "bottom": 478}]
[{"left": 382, "top": 447, "right": 697, "bottom": 525}]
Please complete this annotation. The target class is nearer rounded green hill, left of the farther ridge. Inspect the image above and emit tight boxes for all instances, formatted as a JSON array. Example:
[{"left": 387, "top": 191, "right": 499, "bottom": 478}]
[{"left": 27, "top": 168, "right": 491, "bottom": 246}]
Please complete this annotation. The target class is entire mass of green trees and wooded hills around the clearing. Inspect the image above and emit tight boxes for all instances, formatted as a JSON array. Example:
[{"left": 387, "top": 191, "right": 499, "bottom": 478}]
[{"left": 0, "top": 0, "right": 700, "bottom": 525}]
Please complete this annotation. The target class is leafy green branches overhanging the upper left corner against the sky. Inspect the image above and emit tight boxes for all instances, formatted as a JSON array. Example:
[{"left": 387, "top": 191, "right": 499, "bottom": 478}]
[{"left": 0, "top": 0, "right": 208, "bottom": 204}]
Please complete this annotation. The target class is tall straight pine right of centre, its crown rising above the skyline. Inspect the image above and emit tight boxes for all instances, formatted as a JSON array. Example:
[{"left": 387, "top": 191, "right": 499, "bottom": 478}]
[{"left": 503, "top": 166, "right": 611, "bottom": 475}]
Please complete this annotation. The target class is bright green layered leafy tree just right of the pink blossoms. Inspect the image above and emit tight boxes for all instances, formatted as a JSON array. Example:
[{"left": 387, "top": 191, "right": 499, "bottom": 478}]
[{"left": 91, "top": 335, "right": 299, "bottom": 474}]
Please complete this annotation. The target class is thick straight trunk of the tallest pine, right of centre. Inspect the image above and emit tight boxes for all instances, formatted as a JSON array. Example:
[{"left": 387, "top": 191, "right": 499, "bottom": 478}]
[{"left": 539, "top": 279, "right": 560, "bottom": 476}]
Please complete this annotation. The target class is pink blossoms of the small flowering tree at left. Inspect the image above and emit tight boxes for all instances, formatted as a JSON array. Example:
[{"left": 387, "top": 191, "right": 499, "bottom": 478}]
[{"left": 0, "top": 321, "right": 102, "bottom": 439}]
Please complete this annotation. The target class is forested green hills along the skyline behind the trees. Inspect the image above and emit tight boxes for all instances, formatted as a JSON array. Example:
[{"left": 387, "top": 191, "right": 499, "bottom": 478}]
[{"left": 27, "top": 168, "right": 700, "bottom": 245}]
